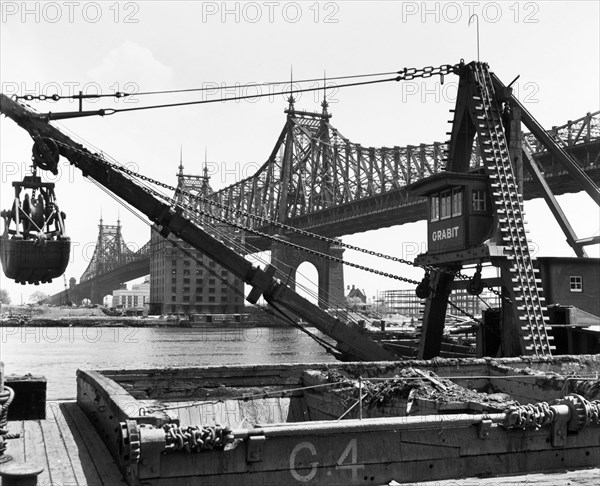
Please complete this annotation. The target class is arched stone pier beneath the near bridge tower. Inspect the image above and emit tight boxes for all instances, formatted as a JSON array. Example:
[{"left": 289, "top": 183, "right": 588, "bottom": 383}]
[{"left": 271, "top": 236, "right": 345, "bottom": 309}]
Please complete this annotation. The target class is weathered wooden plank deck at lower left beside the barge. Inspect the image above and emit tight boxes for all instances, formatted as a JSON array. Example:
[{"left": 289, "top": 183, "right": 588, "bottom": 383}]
[{"left": 6, "top": 401, "right": 126, "bottom": 486}]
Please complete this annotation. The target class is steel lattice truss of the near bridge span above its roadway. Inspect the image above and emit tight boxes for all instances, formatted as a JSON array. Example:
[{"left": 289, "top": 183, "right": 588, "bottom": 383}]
[{"left": 206, "top": 112, "right": 600, "bottom": 234}]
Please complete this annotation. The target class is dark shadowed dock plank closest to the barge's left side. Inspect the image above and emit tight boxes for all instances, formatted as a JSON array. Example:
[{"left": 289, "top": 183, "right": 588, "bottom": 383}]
[{"left": 64, "top": 403, "right": 126, "bottom": 486}]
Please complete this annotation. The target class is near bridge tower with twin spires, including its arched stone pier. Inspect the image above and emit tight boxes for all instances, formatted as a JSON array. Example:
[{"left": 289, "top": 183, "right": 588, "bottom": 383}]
[{"left": 271, "top": 94, "right": 344, "bottom": 308}]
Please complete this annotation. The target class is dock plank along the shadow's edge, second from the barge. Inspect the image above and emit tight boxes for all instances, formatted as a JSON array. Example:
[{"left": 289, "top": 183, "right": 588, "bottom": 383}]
[{"left": 52, "top": 403, "right": 103, "bottom": 486}]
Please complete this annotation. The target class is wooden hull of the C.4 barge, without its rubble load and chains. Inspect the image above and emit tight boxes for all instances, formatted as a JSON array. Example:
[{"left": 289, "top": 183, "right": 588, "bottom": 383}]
[{"left": 78, "top": 356, "right": 600, "bottom": 486}]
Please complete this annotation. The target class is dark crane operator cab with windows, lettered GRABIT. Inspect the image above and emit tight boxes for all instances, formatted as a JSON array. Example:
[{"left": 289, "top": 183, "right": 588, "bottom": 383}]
[{"left": 410, "top": 172, "right": 494, "bottom": 254}]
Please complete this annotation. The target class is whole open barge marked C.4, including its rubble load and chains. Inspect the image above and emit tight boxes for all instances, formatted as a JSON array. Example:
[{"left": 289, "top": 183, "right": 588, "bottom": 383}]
[{"left": 72, "top": 356, "right": 600, "bottom": 486}]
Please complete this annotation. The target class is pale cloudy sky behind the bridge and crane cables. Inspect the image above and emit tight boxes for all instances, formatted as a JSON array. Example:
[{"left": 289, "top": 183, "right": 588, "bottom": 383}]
[{"left": 0, "top": 1, "right": 600, "bottom": 302}]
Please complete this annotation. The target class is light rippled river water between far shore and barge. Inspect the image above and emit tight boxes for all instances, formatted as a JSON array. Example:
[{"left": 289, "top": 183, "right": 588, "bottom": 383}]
[{"left": 0, "top": 326, "right": 335, "bottom": 400}]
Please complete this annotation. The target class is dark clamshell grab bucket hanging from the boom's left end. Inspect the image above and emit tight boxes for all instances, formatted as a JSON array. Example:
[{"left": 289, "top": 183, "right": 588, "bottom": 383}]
[{"left": 0, "top": 171, "right": 71, "bottom": 285}]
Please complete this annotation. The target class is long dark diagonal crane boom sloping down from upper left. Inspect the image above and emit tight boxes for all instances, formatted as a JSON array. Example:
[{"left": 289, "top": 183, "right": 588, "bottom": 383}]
[{"left": 0, "top": 94, "right": 398, "bottom": 361}]
